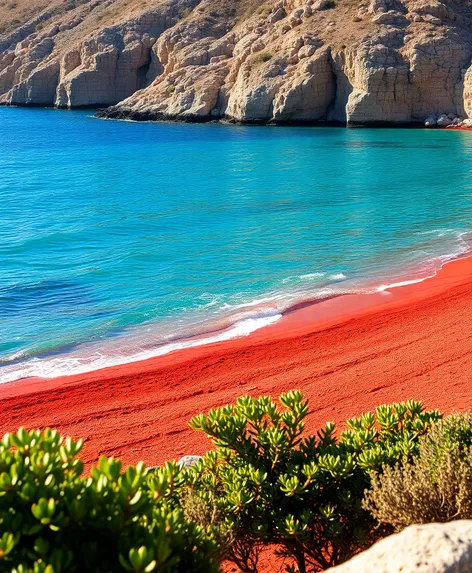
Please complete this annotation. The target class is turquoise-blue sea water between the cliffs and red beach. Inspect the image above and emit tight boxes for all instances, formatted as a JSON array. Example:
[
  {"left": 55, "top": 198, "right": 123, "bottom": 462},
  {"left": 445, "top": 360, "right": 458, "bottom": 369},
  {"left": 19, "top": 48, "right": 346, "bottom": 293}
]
[{"left": 0, "top": 108, "right": 472, "bottom": 382}]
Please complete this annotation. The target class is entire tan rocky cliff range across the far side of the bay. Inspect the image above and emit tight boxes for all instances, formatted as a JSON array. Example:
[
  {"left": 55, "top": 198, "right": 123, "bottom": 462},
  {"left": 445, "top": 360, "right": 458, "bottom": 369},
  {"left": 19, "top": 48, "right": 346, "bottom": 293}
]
[{"left": 0, "top": 0, "right": 472, "bottom": 125}]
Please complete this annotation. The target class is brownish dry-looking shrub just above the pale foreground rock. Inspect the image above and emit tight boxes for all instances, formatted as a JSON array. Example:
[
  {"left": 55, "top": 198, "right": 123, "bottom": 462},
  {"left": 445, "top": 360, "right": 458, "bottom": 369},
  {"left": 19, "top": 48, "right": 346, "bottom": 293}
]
[{"left": 365, "top": 414, "right": 472, "bottom": 530}]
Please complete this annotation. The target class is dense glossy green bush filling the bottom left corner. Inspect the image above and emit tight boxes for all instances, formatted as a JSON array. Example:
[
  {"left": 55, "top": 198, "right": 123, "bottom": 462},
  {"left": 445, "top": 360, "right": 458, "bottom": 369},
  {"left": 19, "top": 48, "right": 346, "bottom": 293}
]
[{"left": 0, "top": 429, "right": 218, "bottom": 573}]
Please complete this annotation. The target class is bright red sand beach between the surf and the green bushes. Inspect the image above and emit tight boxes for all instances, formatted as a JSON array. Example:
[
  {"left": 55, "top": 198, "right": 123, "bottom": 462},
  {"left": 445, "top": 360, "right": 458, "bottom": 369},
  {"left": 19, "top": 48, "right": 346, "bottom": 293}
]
[{"left": 0, "top": 257, "right": 472, "bottom": 465}]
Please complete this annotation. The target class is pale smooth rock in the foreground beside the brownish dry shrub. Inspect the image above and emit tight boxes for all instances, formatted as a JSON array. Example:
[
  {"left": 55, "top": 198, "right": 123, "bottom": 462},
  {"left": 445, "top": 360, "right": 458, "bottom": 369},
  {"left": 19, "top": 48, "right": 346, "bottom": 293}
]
[{"left": 329, "top": 521, "right": 472, "bottom": 573}]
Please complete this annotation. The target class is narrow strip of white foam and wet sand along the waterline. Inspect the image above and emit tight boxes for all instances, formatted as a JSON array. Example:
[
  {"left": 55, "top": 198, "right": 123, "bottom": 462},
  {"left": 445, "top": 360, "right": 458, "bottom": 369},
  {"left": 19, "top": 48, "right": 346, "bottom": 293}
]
[{"left": 0, "top": 241, "right": 472, "bottom": 388}]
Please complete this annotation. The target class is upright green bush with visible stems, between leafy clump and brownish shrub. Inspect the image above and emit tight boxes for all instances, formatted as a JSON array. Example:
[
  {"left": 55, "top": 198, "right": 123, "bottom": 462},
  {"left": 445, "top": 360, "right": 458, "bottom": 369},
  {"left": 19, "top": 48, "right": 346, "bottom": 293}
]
[{"left": 187, "top": 392, "right": 440, "bottom": 572}]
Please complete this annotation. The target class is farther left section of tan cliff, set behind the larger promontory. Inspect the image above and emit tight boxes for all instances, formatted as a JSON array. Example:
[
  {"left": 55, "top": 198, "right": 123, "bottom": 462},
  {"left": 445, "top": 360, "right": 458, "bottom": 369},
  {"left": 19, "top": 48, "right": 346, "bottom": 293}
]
[{"left": 0, "top": 0, "right": 197, "bottom": 108}]
